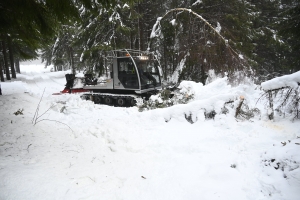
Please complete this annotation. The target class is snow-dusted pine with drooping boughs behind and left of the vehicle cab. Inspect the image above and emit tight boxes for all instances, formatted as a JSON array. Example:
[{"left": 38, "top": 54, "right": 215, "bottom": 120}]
[{"left": 46, "top": 0, "right": 136, "bottom": 75}]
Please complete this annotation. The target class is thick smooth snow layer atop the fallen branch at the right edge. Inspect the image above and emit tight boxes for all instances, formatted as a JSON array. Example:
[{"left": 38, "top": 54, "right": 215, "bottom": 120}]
[{"left": 261, "top": 71, "right": 300, "bottom": 90}]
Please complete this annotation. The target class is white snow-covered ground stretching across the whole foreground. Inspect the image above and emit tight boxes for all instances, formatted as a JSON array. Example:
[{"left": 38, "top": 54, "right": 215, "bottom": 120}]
[{"left": 0, "top": 66, "right": 300, "bottom": 200}]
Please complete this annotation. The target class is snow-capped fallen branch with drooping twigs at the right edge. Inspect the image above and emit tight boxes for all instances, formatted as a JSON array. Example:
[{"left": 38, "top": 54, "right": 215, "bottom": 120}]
[{"left": 261, "top": 71, "right": 300, "bottom": 120}]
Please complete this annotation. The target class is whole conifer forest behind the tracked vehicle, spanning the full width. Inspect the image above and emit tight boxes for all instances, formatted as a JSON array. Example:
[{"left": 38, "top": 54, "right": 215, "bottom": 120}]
[{"left": 0, "top": 0, "right": 300, "bottom": 84}]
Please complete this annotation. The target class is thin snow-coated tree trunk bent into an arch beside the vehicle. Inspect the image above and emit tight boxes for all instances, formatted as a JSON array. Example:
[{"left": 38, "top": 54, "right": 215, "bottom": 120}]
[{"left": 148, "top": 8, "right": 242, "bottom": 58}]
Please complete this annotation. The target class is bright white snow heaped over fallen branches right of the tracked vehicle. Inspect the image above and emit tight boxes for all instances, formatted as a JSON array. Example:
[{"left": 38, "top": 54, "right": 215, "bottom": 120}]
[{"left": 144, "top": 77, "right": 264, "bottom": 123}]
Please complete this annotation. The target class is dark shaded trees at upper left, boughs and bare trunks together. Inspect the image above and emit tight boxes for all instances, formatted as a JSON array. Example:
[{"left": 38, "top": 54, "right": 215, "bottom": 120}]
[{"left": 0, "top": 0, "right": 135, "bottom": 81}]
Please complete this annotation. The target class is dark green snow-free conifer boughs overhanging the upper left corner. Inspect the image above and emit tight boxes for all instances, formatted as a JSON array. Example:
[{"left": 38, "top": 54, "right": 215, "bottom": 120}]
[{"left": 0, "top": 0, "right": 137, "bottom": 80}]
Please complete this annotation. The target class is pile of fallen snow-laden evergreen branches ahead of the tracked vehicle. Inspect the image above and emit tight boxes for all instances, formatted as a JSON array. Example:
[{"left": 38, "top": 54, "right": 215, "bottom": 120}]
[{"left": 137, "top": 77, "right": 260, "bottom": 124}]
